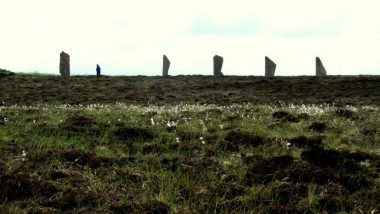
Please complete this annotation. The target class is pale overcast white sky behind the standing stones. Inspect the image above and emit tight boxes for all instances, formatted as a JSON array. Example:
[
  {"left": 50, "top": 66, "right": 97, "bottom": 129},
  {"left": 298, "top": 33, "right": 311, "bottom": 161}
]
[{"left": 0, "top": 0, "right": 380, "bottom": 76}]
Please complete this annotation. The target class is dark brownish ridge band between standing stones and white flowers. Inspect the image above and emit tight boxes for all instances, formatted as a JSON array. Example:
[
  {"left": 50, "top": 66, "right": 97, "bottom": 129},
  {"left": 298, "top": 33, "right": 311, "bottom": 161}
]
[{"left": 0, "top": 75, "right": 380, "bottom": 106}]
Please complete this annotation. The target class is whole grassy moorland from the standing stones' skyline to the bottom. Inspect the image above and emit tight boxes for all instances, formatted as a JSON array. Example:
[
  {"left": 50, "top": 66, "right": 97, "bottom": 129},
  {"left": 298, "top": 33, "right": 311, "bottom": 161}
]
[{"left": 0, "top": 74, "right": 380, "bottom": 213}]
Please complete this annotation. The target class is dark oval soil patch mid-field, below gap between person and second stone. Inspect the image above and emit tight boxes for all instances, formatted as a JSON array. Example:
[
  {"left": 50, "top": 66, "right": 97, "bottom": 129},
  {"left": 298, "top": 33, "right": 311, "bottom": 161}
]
[{"left": 114, "top": 126, "right": 155, "bottom": 141}]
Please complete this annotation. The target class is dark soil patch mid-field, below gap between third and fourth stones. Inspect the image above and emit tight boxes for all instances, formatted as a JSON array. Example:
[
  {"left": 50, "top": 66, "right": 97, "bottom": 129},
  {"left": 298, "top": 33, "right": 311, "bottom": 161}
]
[{"left": 221, "top": 131, "right": 265, "bottom": 151}]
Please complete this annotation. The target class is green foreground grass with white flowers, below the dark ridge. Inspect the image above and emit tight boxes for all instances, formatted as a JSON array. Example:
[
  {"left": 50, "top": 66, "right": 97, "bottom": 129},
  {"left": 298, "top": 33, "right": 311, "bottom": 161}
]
[{"left": 0, "top": 103, "right": 380, "bottom": 213}]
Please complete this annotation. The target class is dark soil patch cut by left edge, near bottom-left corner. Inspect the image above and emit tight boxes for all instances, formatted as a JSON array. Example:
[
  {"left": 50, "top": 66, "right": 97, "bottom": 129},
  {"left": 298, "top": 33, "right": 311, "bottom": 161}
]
[{"left": 0, "top": 172, "right": 57, "bottom": 201}]
